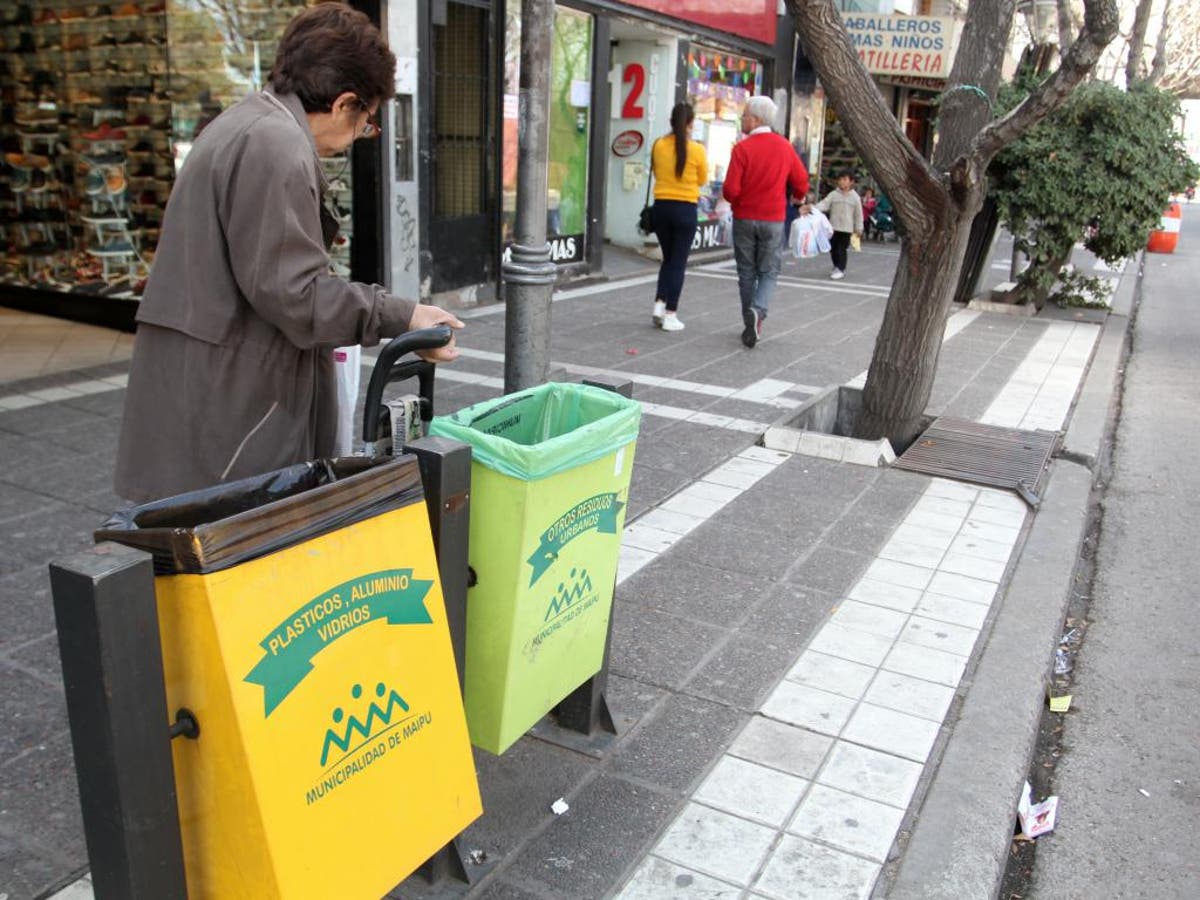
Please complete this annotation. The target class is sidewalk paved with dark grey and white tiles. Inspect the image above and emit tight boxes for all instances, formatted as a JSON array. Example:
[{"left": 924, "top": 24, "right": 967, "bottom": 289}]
[{"left": 0, "top": 232, "right": 1132, "bottom": 900}]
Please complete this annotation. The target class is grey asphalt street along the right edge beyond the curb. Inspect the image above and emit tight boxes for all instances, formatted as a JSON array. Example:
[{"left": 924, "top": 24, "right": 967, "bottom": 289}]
[{"left": 1030, "top": 206, "right": 1200, "bottom": 900}]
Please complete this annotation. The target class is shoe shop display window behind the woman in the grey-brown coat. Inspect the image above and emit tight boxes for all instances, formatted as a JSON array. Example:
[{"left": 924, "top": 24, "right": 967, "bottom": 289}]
[{"left": 0, "top": 0, "right": 350, "bottom": 298}]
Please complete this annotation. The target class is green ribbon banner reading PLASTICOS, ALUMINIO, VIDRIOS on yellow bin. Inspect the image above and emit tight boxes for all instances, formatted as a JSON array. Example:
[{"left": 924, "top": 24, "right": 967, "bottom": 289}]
[{"left": 245, "top": 569, "right": 433, "bottom": 718}]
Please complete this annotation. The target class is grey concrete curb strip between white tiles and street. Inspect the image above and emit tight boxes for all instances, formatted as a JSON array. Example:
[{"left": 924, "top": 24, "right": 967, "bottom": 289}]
[{"left": 887, "top": 254, "right": 1142, "bottom": 900}]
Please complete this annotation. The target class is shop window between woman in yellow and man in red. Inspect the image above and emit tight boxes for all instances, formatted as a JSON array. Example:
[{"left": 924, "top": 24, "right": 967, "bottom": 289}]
[{"left": 688, "top": 46, "right": 762, "bottom": 248}]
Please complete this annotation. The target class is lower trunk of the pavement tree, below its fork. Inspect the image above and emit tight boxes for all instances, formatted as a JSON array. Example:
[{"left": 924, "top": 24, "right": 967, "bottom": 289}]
[{"left": 854, "top": 200, "right": 983, "bottom": 452}]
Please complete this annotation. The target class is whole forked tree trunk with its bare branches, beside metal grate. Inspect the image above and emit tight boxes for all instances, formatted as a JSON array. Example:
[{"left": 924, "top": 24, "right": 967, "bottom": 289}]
[{"left": 786, "top": 0, "right": 1116, "bottom": 446}]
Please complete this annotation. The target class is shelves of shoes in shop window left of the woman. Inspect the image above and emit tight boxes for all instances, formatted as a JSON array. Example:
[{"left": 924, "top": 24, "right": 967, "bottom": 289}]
[{"left": 0, "top": 0, "right": 174, "bottom": 289}]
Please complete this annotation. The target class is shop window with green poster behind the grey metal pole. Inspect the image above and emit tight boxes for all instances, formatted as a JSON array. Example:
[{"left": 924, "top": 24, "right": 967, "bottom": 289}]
[{"left": 502, "top": 5, "right": 592, "bottom": 264}]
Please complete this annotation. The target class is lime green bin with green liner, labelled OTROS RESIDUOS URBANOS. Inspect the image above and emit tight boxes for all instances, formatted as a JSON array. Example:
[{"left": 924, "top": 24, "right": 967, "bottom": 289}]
[{"left": 430, "top": 383, "right": 641, "bottom": 754}]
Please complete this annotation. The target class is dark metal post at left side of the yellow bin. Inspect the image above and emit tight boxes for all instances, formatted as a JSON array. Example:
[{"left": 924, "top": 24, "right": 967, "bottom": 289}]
[{"left": 50, "top": 544, "right": 187, "bottom": 900}]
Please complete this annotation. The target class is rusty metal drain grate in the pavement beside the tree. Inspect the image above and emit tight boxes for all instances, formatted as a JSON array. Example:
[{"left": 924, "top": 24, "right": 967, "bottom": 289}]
[{"left": 894, "top": 416, "right": 1060, "bottom": 508}]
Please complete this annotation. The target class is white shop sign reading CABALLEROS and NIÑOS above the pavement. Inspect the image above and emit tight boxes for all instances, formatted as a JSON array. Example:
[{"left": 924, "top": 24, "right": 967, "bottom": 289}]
[{"left": 845, "top": 16, "right": 954, "bottom": 79}]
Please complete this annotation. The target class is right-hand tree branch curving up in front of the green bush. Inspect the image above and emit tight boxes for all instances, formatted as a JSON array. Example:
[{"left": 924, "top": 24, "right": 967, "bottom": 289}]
[{"left": 971, "top": 0, "right": 1118, "bottom": 164}]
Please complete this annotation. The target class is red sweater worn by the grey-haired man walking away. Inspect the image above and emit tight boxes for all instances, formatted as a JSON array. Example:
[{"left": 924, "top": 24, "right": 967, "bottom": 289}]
[{"left": 722, "top": 132, "right": 809, "bottom": 222}]
